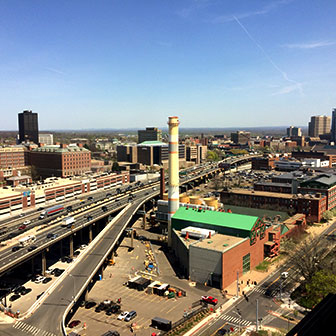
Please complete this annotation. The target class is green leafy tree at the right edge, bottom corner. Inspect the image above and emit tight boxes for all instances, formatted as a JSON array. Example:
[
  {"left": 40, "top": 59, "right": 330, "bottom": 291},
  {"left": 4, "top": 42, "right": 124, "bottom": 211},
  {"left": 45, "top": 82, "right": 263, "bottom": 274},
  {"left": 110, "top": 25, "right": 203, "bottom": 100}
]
[{"left": 306, "top": 270, "right": 336, "bottom": 306}]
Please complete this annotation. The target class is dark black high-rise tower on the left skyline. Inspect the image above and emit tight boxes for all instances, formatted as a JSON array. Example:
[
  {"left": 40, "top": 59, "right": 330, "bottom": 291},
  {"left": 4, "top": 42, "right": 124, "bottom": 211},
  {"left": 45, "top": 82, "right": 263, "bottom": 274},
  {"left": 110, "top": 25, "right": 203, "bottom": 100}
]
[{"left": 18, "top": 111, "right": 39, "bottom": 144}]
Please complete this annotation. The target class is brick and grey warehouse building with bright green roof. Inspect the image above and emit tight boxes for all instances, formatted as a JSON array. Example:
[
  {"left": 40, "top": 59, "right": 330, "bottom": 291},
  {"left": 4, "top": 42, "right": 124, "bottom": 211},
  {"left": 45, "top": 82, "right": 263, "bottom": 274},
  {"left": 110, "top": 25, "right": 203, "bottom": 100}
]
[{"left": 172, "top": 207, "right": 281, "bottom": 289}]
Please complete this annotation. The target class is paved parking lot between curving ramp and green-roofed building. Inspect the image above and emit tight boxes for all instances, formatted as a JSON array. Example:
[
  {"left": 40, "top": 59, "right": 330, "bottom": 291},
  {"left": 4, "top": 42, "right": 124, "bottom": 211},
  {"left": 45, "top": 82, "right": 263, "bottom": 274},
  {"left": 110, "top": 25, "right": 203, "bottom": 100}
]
[{"left": 71, "top": 223, "right": 224, "bottom": 335}]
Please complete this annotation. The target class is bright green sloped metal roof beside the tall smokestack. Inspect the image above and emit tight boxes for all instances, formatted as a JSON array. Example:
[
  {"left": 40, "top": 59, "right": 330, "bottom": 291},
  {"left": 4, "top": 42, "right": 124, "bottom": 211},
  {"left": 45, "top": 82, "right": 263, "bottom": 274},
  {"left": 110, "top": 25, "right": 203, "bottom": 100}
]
[{"left": 172, "top": 207, "right": 258, "bottom": 231}]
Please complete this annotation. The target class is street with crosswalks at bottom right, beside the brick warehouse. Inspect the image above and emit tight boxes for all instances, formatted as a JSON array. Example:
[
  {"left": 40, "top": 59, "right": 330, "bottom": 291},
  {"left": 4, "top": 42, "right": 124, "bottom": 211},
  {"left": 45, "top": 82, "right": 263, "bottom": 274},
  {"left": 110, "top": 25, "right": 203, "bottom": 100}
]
[{"left": 194, "top": 222, "right": 336, "bottom": 336}]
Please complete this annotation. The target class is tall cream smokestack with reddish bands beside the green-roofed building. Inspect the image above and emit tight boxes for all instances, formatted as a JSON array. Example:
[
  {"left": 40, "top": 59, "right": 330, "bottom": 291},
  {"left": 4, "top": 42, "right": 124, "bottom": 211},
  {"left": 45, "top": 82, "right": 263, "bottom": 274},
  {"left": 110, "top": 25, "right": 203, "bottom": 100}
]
[{"left": 168, "top": 117, "right": 180, "bottom": 247}]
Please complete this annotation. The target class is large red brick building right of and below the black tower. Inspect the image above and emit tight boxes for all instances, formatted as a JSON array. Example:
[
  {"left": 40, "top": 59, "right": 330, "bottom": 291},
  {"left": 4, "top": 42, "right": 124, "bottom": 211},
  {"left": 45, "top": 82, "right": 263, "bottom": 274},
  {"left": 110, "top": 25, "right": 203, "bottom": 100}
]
[{"left": 29, "top": 144, "right": 91, "bottom": 177}]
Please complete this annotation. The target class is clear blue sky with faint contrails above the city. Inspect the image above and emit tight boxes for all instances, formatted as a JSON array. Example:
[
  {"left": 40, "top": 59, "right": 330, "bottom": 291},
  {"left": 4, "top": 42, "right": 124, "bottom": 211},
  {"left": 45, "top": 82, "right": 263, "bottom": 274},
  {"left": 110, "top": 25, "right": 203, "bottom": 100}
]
[{"left": 0, "top": 0, "right": 336, "bottom": 130}]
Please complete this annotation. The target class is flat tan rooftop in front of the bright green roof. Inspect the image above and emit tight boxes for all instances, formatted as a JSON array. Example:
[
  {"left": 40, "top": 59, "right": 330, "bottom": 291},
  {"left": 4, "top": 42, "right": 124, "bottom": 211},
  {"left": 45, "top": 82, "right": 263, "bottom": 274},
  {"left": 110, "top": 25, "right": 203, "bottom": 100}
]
[{"left": 176, "top": 231, "right": 249, "bottom": 253}]
